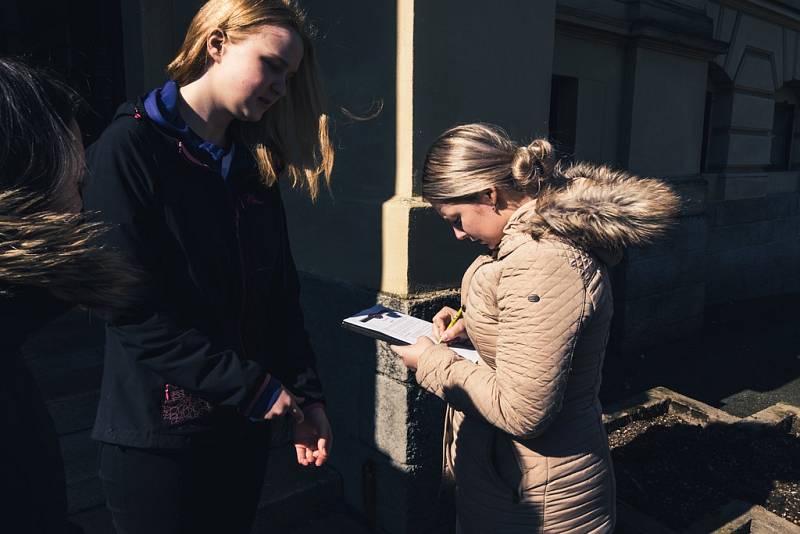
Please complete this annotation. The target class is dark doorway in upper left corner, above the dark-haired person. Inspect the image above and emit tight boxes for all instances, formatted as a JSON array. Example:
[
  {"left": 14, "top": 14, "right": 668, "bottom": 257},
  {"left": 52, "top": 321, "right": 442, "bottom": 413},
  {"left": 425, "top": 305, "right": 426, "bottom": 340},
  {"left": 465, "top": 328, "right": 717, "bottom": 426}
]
[{"left": 0, "top": 0, "right": 125, "bottom": 145}]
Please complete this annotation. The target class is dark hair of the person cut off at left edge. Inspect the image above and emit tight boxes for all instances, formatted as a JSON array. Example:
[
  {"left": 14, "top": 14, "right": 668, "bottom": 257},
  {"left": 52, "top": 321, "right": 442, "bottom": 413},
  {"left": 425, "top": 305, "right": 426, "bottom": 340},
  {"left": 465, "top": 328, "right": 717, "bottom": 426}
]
[{"left": 0, "top": 58, "right": 85, "bottom": 211}]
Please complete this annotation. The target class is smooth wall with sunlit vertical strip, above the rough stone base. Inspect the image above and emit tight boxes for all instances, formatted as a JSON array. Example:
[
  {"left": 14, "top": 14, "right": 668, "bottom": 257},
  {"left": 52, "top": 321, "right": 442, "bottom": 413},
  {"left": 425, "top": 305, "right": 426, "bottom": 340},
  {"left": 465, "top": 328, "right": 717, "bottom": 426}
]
[{"left": 288, "top": 0, "right": 555, "bottom": 295}]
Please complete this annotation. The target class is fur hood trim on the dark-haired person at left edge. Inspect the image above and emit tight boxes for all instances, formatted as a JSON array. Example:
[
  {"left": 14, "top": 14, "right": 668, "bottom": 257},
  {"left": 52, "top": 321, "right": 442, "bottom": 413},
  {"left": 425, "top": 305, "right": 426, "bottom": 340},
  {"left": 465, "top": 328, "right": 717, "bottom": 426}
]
[{"left": 0, "top": 191, "right": 140, "bottom": 311}]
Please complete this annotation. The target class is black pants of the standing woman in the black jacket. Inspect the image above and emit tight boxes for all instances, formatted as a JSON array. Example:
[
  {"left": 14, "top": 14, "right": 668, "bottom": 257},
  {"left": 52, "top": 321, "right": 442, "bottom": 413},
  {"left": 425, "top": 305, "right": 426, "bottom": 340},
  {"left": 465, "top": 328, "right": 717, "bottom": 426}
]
[{"left": 100, "top": 425, "right": 269, "bottom": 534}]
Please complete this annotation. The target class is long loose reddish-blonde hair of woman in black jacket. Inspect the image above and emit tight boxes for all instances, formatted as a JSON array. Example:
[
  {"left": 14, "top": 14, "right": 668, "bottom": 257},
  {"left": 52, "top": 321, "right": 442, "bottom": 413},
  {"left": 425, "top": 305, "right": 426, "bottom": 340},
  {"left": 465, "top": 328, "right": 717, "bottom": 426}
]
[{"left": 167, "top": 0, "right": 334, "bottom": 199}]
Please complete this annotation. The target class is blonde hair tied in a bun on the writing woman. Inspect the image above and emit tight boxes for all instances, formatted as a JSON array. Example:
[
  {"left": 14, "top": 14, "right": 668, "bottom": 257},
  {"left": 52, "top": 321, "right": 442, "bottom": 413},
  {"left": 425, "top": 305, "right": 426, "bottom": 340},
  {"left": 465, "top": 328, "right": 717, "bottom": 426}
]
[{"left": 422, "top": 123, "right": 562, "bottom": 203}]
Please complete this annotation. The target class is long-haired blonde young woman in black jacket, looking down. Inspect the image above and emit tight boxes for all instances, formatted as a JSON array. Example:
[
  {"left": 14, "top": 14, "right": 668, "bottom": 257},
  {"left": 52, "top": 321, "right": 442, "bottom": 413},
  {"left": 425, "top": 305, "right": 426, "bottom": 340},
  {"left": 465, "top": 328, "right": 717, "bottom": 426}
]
[{"left": 83, "top": 0, "right": 333, "bottom": 534}]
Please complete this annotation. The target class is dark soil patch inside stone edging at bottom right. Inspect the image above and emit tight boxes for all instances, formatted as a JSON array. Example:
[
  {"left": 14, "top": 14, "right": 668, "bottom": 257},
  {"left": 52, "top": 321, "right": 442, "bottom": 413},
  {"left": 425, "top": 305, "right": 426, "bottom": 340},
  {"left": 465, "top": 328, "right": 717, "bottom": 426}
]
[{"left": 609, "top": 414, "right": 800, "bottom": 529}]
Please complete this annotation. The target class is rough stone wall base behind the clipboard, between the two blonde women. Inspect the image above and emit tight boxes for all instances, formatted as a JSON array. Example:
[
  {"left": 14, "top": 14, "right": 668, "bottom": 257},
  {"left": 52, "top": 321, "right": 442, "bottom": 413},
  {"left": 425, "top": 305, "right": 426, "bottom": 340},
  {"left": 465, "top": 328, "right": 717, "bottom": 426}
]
[{"left": 301, "top": 274, "right": 458, "bottom": 534}]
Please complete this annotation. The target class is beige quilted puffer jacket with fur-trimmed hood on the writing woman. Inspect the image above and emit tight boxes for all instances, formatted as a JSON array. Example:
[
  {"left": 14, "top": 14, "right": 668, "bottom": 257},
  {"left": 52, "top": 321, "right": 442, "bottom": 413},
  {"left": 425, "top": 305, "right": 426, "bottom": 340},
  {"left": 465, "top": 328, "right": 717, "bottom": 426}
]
[{"left": 416, "top": 165, "right": 678, "bottom": 534}]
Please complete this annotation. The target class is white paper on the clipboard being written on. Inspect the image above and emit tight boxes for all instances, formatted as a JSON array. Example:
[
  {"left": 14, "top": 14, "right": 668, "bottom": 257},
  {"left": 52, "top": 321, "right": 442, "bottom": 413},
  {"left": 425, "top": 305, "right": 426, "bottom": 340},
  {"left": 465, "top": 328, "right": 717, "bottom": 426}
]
[{"left": 343, "top": 304, "right": 478, "bottom": 363}]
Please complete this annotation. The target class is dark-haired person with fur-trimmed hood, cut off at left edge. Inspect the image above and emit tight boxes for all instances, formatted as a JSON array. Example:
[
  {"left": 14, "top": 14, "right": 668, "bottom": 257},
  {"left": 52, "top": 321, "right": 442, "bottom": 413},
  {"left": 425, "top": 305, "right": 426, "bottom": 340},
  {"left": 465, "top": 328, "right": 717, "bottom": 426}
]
[{"left": 0, "top": 58, "right": 136, "bottom": 534}]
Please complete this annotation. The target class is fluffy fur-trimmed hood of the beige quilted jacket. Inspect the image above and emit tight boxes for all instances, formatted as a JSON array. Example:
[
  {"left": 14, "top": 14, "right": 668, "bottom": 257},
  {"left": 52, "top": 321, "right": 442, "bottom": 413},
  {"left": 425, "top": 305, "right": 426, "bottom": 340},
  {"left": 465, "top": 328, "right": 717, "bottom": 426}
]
[{"left": 499, "top": 163, "right": 680, "bottom": 263}]
